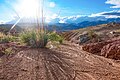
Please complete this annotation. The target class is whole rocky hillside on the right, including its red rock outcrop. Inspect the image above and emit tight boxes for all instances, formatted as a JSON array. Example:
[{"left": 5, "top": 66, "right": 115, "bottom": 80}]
[{"left": 63, "top": 23, "right": 120, "bottom": 60}]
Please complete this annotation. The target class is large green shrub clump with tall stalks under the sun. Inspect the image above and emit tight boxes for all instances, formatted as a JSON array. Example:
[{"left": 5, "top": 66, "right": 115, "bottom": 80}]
[{"left": 20, "top": 31, "right": 48, "bottom": 47}]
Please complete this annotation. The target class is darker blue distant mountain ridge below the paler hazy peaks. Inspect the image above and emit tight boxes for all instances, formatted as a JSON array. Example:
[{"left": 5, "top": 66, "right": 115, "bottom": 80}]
[{"left": 47, "top": 18, "right": 120, "bottom": 31}]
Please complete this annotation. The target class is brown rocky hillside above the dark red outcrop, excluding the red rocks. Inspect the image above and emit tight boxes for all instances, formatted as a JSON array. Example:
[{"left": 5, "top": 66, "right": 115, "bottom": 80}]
[{"left": 62, "top": 23, "right": 120, "bottom": 44}]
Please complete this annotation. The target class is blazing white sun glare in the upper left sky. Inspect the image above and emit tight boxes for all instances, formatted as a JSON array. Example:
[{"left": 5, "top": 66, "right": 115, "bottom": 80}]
[{"left": 17, "top": 0, "right": 40, "bottom": 17}]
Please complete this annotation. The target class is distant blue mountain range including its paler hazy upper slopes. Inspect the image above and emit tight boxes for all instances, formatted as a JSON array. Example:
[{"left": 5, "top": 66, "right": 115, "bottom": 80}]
[{"left": 49, "top": 17, "right": 120, "bottom": 31}]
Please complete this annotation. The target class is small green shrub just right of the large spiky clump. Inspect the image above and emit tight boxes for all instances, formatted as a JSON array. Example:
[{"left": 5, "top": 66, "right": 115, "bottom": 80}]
[{"left": 49, "top": 33, "right": 64, "bottom": 44}]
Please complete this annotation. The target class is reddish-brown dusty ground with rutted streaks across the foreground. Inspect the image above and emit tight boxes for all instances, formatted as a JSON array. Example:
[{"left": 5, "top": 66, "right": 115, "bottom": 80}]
[{"left": 0, "top": 42, "right": 120, "bottom": 80}]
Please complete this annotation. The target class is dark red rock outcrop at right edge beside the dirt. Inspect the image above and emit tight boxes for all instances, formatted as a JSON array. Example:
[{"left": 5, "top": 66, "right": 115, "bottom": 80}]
[{"left": 82, "top": 39, "right": 120, "bottom": 59}]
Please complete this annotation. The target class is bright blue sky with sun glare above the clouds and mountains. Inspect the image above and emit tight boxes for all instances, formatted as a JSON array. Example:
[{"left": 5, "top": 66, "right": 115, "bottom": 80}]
[{"left": 0, "top": 0, "right": 120, "bottom": 22}]
